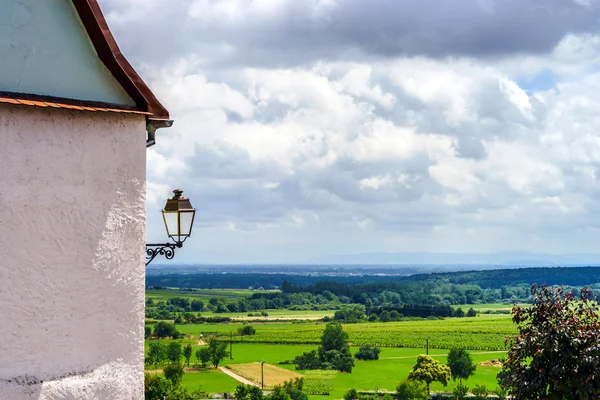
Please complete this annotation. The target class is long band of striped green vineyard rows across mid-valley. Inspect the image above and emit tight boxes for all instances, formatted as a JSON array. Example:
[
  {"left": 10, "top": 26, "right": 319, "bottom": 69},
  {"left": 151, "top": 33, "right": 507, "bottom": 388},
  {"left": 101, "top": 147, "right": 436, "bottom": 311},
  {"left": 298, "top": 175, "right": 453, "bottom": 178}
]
[{"left": 168, "top": 314, "right": 516, "bottom": 350}]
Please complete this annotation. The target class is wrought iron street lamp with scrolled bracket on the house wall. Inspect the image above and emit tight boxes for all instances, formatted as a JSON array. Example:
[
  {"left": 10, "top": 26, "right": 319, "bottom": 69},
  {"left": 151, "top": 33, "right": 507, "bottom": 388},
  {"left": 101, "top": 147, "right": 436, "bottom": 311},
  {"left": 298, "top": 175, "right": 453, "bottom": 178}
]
[{"left": 146, "top": 190, "right": 196, "bottom": 265}]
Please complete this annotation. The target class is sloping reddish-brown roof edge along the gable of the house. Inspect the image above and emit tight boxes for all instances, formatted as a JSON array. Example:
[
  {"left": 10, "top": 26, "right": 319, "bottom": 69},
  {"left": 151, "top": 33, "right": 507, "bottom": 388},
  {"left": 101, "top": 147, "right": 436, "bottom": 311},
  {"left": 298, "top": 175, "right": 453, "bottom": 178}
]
[{"left": 72, "top": 0, "right": 169, "bottom": 120}]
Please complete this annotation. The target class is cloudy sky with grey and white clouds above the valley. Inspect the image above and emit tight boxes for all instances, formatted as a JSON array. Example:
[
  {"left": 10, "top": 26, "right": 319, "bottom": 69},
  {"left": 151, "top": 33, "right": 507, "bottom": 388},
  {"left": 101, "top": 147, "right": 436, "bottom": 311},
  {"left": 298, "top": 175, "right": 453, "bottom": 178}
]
[{"left": 100, "top": 0, "right": 600, "bottom": 263}]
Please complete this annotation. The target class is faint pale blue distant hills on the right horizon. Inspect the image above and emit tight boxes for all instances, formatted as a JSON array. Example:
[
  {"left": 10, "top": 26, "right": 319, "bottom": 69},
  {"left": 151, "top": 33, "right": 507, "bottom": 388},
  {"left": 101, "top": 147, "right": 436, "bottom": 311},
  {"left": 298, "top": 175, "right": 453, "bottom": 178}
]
[{"left": 310, "top": 251, "right": 600, "bottom": 267}]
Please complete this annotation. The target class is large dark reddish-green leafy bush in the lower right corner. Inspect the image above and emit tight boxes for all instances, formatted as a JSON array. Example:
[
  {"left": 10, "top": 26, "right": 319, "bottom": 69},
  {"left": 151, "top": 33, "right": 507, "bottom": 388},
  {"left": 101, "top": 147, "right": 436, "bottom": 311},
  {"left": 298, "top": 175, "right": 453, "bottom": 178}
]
[{"left": 498, "top": 285, "right": 600, "bottom": 400}]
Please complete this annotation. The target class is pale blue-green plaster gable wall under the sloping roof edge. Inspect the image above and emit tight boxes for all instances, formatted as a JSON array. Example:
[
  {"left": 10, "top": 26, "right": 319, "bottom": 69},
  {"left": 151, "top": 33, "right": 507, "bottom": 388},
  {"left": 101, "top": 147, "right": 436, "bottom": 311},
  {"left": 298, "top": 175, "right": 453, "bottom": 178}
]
[{"left": 0, "top": 0, "right": 135, "bottom": 105}]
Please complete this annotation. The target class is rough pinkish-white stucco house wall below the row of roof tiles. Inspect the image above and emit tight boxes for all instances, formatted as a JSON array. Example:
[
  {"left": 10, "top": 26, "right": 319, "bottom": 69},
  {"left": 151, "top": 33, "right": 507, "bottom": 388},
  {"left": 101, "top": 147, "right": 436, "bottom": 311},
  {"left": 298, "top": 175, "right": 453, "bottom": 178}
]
[{"left": 0, "top": 104, "right": 146, "bottom": 400}]
